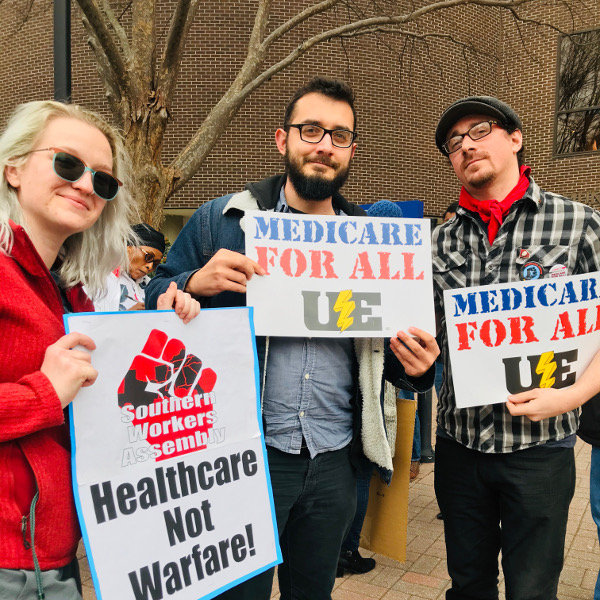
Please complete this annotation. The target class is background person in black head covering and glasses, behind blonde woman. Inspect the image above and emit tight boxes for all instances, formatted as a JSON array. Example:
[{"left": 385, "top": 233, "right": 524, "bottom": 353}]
[{"left": 94, "top": 223, "right": 165, "bottom": 312}]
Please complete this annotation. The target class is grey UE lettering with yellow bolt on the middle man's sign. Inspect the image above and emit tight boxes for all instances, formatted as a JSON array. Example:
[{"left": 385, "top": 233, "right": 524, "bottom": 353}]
[{"left": 302, "top": 290, "right": 382, "bottom": 331}]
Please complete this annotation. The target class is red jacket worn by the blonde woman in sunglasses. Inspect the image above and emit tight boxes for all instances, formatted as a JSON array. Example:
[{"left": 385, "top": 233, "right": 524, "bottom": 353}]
[{"left": 0, "top": 222, "right": 94, "bottom": 570}]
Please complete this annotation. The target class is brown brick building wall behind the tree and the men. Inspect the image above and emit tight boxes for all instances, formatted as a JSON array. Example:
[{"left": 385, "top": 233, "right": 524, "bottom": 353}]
[{"left": 0, "top": 0, "right": 600, "bottom": 215}]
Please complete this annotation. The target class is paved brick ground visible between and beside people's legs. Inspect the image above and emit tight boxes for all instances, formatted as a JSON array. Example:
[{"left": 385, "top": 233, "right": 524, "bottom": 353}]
[{"left": 80, "top": 440, "right": 600, "bottom": 600}]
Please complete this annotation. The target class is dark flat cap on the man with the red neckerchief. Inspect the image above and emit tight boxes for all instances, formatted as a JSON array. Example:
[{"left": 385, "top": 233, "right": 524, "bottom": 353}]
[{"left": 435, "top": 96, "right": 523, "bottom": 155}]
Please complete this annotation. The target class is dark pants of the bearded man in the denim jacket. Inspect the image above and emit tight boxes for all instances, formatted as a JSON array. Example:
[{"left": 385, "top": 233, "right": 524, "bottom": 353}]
[{"left": 217, "top": 447, "right": 356, "bottom": 600}]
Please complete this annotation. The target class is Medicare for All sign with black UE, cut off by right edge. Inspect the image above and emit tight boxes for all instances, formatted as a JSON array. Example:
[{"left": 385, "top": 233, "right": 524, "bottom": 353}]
[{"left": 444, "top": 273, "right": 600, "bottom": 408}]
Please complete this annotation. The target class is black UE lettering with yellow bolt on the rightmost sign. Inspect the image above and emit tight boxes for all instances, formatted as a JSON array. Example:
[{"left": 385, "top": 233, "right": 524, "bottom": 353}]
[{"left": 502, "top": 350, "right": 577, "bottom": 394}]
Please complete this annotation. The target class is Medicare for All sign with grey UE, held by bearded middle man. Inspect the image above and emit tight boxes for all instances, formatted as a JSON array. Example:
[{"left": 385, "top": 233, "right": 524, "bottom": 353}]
[{"left": 245, "top": 211, "right": 435, "bottom": 337}]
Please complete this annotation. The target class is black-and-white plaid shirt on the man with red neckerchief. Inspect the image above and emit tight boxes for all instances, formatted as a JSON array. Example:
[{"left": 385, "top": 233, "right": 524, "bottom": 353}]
[{"left": 432, "top": 179, "right": 600, "bottom": 453}]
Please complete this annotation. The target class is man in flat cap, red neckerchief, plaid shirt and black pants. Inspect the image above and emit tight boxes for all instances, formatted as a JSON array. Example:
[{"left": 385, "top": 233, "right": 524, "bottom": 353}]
[{"left": 432, "top": 96, "right": 600, "bottom": 600}]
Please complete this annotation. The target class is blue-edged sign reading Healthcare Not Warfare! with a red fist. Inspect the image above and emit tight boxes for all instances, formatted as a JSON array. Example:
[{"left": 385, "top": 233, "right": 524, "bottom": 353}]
[{"left": 65, "top": 308, "right": 281, "bottom": 600}]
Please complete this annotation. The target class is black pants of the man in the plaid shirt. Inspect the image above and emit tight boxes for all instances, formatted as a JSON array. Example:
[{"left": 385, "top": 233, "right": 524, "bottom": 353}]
[{"left": 435, "top": 437, "right": 575, "bottom": 600}]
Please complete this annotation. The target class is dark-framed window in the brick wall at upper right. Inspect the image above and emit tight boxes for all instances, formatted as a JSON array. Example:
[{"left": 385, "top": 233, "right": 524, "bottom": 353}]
[{"left": 555, "top": 30, "right": 600, "bottom": 154}]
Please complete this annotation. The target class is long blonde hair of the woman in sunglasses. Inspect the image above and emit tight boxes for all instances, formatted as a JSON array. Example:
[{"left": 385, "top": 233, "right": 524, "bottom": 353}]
[{"left": 0, "top": 100, "right": 133, "bottom": 295}]
